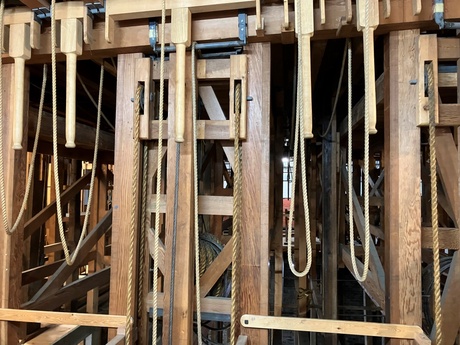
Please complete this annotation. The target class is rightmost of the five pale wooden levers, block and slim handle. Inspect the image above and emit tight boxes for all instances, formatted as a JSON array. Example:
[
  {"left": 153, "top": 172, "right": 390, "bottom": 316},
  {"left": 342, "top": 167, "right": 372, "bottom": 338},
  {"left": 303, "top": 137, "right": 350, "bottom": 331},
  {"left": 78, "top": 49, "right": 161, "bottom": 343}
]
[{"left": 356, "top": 0, "right": 379, "bottom": 134}]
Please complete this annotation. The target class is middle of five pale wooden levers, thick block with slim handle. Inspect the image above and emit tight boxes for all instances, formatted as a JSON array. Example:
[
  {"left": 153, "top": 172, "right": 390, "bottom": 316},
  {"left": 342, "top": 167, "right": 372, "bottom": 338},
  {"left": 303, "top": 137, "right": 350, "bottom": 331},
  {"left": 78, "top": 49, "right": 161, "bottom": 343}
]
[{"left": 171, "top": 8, "right": 192, "bottom": 143}]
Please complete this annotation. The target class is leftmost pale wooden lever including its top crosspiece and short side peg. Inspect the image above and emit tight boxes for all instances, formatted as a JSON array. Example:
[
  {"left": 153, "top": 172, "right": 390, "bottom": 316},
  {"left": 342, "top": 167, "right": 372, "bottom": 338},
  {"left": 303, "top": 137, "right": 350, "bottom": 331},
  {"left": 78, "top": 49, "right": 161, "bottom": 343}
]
[{"left": 4, "top": 9, "right": 40, "bottom": 150}]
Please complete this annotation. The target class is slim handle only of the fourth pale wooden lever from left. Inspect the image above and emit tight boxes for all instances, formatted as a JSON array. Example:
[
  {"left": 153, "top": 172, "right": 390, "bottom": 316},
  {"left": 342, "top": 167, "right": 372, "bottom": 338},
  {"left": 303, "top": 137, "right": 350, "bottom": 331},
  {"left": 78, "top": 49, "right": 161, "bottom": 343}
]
[{"left": 301, "top": 34, "right": 313, "bottom": 139}]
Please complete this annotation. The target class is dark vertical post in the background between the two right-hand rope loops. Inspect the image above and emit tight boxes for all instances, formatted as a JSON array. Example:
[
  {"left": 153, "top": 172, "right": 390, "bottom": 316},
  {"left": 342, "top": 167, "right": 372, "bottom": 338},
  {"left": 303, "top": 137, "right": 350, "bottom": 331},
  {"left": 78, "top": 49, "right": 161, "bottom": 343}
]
[{"left": 322, "top": 119, "right": 339, "bottom": 344}]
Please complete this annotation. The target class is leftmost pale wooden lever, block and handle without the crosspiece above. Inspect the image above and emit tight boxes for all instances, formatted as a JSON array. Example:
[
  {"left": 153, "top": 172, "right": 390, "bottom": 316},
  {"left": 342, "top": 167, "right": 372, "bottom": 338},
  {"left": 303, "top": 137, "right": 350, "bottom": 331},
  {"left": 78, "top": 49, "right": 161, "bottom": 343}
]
[{"left": 9, "top": 24, "right": 32, "bottom": 150}]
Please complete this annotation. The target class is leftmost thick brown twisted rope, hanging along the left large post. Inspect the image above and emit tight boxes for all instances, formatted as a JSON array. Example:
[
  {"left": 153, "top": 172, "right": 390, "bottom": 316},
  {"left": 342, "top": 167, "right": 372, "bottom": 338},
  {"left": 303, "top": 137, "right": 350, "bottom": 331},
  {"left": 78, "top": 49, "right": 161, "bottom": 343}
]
[{"left": 126, "top": 85, "right": 142, "bottom": 345}]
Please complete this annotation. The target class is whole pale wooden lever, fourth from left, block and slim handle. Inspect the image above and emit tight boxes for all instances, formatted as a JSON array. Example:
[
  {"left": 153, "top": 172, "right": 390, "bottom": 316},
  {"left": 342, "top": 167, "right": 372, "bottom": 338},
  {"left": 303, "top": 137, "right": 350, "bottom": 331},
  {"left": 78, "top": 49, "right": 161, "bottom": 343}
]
[{"left": 295, "top": 1, "right": 315, "bottom": 139}]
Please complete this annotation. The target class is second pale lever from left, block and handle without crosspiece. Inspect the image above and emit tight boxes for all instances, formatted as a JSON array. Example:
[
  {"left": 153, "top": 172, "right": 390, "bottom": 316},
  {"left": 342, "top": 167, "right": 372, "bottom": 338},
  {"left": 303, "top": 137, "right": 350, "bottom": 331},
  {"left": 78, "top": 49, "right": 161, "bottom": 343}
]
[{"left": 61, "top": 18, "right": 83, "bottom": 148}]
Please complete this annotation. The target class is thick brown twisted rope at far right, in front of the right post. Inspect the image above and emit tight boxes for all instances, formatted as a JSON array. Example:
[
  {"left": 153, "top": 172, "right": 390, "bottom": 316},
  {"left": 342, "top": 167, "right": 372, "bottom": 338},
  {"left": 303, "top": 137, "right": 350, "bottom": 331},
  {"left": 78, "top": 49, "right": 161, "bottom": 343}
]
[{"left": 428, "top": 62, "right": 442, "bottom": 345}]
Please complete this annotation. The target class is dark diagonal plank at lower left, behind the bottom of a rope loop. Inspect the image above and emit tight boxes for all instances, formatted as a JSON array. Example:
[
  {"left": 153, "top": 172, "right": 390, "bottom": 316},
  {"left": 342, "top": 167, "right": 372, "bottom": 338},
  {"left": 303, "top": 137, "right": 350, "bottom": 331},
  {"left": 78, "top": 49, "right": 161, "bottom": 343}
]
[{"left": 23, "top": 209, "right": 113, "bottom": 308}]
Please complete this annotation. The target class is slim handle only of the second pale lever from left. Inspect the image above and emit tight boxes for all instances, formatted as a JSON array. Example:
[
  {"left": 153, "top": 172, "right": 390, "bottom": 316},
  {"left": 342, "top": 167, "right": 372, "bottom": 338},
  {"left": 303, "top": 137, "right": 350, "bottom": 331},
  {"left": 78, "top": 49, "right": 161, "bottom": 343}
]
[{"left": 65, "top": 53, "right": 77, "bottom": 148}]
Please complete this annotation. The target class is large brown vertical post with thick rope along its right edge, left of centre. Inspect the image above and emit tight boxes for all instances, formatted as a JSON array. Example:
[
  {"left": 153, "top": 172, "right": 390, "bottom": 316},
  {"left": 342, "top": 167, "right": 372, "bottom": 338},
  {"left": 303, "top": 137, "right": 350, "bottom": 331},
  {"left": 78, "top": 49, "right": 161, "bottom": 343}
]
[{"left": 109, "top": 54, "right": 142, "bottom": 337}]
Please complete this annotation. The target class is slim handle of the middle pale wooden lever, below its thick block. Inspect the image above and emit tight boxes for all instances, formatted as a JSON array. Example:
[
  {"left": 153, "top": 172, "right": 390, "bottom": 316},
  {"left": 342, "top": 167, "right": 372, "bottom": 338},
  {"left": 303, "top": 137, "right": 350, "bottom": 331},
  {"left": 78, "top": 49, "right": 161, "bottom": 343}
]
[{"left": 174, "top": 43, "right": 186, "bottom": 143}]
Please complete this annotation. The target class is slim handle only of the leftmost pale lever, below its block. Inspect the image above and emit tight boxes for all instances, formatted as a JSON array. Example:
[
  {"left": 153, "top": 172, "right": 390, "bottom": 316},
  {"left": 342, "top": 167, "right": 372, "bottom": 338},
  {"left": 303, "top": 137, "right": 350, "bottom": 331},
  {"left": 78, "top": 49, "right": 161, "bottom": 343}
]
[{"left": 13, "top": 58, "right": 26, "bottom": 150}]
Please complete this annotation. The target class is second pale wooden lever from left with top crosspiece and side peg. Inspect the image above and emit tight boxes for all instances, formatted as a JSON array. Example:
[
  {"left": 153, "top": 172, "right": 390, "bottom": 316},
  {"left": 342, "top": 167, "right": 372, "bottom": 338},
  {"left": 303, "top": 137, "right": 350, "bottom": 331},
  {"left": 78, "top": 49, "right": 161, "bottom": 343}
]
[{"left": 56, "top": 1, "right": 92, "bottom": 148}]
